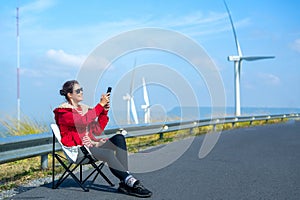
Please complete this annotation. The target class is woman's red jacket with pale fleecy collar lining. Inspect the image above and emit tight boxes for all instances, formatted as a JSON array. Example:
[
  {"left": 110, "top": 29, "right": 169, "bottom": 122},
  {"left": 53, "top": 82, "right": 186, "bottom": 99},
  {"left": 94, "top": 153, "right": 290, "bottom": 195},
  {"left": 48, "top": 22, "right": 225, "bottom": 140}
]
[{"left": 53, "top": 103, "right": 109, "bottom": 147}]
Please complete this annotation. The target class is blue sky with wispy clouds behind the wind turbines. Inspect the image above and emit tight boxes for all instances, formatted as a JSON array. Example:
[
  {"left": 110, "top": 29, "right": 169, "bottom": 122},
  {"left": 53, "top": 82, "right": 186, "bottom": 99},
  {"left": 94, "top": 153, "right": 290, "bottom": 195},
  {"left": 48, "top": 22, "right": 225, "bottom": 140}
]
[{"left": 0, "top": 0, "right": 300, "bottom": 121}]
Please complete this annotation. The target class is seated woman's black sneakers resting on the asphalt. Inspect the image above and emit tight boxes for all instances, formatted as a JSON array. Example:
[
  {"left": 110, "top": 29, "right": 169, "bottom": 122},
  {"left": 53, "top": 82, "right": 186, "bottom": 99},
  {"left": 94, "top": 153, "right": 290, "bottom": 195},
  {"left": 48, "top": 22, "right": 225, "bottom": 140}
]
[{"left": 118, "top": 181, "right": 152, "bottom": 198}]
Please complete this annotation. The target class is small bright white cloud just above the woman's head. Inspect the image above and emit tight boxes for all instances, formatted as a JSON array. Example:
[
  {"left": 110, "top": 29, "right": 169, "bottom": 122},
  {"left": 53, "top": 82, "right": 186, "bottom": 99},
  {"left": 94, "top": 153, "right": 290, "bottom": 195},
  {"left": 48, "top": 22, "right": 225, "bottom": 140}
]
[{"left": 46, "top": 49, "right": 86, "bottom": 67}]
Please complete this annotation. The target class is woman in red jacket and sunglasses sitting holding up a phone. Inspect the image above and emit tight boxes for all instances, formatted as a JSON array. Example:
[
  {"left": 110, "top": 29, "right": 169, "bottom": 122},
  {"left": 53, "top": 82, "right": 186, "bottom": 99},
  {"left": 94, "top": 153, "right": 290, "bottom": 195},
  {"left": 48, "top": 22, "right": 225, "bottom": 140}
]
[{"left": 54, "top": 80, "right": 152, "bottom": 197}]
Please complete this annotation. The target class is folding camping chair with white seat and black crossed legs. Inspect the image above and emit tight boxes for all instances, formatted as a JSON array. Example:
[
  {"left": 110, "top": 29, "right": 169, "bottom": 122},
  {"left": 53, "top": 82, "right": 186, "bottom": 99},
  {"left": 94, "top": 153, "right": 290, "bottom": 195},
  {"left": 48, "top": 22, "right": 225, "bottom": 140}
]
[{"left": 50, "top": 124, "right": 114, "bottom": 192}]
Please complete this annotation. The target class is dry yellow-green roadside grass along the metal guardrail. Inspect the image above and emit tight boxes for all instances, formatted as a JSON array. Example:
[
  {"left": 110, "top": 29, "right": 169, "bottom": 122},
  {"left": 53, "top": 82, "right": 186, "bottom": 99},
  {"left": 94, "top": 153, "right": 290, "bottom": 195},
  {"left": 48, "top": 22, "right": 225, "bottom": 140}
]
[{"left": 0, "top": 119, "right": 287, "bottom": 191}]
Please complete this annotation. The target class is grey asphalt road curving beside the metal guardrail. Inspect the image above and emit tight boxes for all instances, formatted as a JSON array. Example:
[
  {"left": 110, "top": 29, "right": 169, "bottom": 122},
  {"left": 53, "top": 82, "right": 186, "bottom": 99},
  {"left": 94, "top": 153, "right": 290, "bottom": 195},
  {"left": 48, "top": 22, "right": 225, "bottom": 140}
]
[{"left": 8, "top": 121, "right": 300, "bottom": 200}]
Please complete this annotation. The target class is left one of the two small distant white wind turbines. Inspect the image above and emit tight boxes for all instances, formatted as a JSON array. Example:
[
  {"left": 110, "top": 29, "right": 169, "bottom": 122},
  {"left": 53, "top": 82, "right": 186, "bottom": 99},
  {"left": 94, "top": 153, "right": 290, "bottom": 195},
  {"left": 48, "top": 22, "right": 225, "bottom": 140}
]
[{"left": 123, "top": 60, "right": 139, "bottom": 124}]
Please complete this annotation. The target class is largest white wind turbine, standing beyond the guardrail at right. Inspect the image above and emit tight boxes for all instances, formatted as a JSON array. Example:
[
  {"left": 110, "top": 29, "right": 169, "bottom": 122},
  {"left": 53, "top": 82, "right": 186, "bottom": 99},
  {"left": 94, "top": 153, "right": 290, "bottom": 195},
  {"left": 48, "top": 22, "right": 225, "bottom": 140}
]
[{"left": 224, "top": 0, "right": 275, "bottom": 116}]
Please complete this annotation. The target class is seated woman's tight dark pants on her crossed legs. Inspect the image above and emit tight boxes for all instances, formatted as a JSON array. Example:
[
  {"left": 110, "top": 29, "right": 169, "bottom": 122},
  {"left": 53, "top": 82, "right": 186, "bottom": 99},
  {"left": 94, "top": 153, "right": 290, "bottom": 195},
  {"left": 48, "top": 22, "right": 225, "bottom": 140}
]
[{"left": 89, "top": 134, "right": 129, "bottom": 181}]
